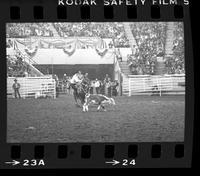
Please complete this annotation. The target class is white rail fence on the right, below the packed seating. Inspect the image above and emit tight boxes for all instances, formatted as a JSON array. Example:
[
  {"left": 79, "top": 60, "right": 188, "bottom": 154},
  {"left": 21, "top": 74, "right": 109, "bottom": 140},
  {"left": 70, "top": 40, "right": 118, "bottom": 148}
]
[{"left": 123, "top": 74, "right": 185, "bottom": 96}]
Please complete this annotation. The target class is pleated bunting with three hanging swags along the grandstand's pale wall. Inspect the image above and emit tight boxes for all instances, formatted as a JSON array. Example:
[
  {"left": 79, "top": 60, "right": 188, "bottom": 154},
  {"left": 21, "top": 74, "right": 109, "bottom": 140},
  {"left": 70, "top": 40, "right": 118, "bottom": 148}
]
[{"left": 8, "top": 38, "right": 108, "bottom": 57}]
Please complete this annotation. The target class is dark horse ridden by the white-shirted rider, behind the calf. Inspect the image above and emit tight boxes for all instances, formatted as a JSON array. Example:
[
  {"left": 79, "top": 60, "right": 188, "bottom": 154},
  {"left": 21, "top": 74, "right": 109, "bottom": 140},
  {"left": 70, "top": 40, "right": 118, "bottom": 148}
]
[{"left": 69, "top": 81, "right": 90, "bottom": 107}]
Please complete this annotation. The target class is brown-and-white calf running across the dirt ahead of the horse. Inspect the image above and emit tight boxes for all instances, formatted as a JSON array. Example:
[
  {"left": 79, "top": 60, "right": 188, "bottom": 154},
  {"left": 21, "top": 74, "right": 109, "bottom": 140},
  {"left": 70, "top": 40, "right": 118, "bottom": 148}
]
[{"left": 83, "top": 94, "right": 115, "bottom": 112}]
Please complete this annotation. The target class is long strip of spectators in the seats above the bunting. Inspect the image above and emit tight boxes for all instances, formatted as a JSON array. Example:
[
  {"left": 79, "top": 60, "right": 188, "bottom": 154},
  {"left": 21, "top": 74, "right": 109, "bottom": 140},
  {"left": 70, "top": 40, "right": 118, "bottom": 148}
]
[{"left": 6, "top": 22, "right": 129, "bottom": 47}]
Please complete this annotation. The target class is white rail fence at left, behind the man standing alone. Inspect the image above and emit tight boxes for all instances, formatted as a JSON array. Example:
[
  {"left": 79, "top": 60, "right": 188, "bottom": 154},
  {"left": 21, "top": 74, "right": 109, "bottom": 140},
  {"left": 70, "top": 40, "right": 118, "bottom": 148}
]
[{"left": 7, "top": 76, "right": 56, "bottom": 98}]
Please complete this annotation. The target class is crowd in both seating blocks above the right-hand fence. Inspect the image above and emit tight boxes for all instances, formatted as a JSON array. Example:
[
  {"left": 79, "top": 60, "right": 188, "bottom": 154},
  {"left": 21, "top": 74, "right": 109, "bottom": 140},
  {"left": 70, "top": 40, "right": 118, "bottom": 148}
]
[{"left": 127, "top": 22, "right": 185, "bottom": 74}]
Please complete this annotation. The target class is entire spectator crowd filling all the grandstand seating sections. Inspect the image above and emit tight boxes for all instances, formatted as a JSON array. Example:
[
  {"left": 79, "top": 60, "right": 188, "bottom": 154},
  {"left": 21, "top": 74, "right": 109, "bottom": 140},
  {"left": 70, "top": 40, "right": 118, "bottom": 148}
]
[{"left": 6, "top": 22, "right": 185, "bottom": 74}]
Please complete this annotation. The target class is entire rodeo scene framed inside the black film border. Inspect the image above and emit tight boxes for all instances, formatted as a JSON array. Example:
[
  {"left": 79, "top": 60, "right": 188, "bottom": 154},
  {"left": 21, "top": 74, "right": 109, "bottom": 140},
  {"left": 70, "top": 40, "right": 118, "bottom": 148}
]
[{"left": 6, "top": 22, "right": 185, "bottom": 143}]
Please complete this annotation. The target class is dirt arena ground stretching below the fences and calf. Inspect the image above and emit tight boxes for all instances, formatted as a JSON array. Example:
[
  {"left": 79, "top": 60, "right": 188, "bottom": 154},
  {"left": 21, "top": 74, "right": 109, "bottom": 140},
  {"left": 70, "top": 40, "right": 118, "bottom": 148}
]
[{"left": 7, "top": 95, "right": 185, "bottom": 143}]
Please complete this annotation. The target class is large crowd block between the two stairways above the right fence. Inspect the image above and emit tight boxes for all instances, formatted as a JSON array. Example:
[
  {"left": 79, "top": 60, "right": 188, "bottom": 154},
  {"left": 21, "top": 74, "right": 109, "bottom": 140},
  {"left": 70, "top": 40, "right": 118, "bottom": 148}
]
[{"left": 127, "top": 22, "right": 166, "bottom": 75}]
